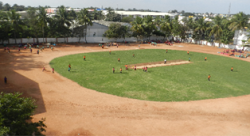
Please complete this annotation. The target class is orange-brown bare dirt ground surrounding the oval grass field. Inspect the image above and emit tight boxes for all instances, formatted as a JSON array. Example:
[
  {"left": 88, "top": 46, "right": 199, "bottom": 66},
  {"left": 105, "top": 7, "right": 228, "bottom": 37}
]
[{"left": 0, "top": 43, "right": 250, "bottom": 136}]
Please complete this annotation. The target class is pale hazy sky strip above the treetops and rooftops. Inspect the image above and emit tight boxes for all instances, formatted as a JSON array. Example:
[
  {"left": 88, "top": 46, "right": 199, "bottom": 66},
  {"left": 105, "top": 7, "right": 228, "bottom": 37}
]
[{"left": 0, "top": 0, "right": 250, "bottom": 14}]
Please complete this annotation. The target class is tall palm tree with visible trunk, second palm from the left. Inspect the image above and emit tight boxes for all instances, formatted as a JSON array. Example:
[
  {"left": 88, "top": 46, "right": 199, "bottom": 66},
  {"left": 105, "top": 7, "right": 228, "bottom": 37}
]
[{"left": 37, "top": 6, "right": 49, "bottom": 42}]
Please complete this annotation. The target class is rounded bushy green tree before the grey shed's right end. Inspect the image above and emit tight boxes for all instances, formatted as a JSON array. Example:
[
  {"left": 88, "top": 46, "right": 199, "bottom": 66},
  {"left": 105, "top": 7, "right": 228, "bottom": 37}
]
[{"left": 103, "top": 23, "right": 123, "bottom": 41}]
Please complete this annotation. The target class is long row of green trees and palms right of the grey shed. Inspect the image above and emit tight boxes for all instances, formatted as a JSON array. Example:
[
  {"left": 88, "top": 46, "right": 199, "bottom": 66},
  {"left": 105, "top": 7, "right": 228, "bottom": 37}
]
[{"left": 105, "top": 12, "right": 249, "bottom": 44}]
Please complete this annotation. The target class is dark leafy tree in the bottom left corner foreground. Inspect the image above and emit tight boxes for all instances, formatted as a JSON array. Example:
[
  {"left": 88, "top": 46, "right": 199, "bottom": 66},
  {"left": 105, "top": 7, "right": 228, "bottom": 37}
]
[{"left": 0, "top": 93, "right": 46, "bottom": 135}]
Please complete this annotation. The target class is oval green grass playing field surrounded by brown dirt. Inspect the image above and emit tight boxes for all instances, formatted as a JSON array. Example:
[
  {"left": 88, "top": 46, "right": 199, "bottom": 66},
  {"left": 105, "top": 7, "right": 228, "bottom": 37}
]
[{"left": 50, "top": 49, "right": 250, "bottom": 101}]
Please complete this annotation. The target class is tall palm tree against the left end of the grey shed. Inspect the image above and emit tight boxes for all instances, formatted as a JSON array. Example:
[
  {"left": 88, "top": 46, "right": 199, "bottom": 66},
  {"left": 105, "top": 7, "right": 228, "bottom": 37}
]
[{"left": 78, "top": 9, "right": 93, "bottom": 43}]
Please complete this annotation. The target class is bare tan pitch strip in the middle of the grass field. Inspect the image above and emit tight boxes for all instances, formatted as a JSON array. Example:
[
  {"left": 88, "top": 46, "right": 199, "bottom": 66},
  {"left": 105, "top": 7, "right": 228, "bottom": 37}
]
[{"left": 128, "top": 60, "right": 190, "bottom": 69}]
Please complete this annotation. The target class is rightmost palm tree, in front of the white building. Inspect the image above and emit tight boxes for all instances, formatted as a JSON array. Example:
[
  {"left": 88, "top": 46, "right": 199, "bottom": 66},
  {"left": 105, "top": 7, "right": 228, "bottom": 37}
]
[{"left": 229, "top": 12, "right": 249, "bottom": 44}]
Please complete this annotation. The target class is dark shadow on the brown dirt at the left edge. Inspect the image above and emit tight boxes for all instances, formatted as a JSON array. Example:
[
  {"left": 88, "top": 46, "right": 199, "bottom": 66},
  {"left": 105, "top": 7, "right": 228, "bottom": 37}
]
[{"left": 0, "top": 52, "right": 46, "bottom": 114}]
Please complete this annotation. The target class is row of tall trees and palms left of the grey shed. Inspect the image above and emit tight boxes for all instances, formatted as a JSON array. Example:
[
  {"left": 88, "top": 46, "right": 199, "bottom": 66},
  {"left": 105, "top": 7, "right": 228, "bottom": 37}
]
[{"left": 0, "top": 6, "right": 104, "bottom": 42}]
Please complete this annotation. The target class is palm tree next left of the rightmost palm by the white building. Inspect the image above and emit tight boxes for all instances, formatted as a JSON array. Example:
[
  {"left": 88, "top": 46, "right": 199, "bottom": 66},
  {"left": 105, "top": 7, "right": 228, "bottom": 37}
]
[{"left": 207, "top": 16, "right": 223, "bottom": 47}]
